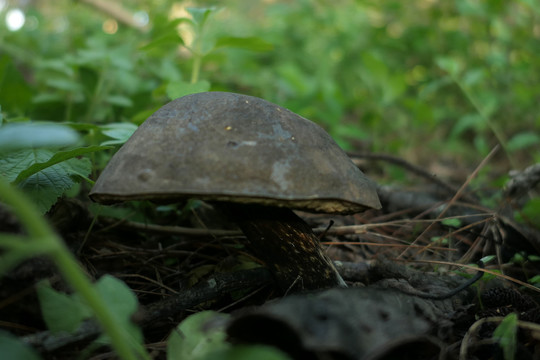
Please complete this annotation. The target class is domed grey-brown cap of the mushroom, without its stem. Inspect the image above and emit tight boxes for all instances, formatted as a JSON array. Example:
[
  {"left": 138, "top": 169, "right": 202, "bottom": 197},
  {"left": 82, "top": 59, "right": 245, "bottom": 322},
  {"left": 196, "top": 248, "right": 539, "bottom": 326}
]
[{"left": 90, "top": 92, "right": 381, "bottom": 214}]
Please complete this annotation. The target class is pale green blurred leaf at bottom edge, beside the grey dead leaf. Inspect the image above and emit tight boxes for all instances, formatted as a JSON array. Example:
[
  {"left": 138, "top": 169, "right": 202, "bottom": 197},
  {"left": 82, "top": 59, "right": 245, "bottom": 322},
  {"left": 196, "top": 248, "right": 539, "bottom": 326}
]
[{"left": 167, "top": 311, "right": 230, "bottom": 360}]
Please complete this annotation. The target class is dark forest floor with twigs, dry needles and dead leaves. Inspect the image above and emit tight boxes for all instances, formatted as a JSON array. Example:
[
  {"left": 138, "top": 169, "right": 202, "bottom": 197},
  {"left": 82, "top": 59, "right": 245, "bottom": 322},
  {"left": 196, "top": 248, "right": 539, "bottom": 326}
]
[{"left": 0, "top": 153, "right": 540, "bottom": 360}]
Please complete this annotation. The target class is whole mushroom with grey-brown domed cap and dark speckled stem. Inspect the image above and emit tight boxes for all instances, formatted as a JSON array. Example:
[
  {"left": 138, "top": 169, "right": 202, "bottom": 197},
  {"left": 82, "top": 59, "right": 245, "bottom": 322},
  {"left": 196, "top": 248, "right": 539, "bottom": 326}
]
[{"left": 90, "top": 92, "right": 381, "bottom": 291}]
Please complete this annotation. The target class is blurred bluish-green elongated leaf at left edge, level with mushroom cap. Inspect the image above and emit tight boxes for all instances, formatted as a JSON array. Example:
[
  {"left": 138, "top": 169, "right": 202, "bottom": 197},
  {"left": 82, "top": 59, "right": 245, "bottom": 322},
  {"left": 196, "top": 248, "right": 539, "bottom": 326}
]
[{"left": 0, "top": 122, "right": 79, "bottom": 152}]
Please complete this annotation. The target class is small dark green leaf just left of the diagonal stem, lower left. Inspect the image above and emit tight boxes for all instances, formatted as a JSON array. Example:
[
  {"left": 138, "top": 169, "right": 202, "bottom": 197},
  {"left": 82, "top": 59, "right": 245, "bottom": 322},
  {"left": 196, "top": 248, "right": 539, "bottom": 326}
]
[{"left": 37, "top": 283, "right": 91, "bottom": 332}]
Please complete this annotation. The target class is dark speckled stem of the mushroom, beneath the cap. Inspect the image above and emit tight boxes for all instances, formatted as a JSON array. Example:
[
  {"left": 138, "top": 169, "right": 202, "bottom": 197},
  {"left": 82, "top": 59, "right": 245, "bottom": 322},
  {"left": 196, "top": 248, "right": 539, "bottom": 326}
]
[{"left": 224, "top": 203, "right": 347, "bottom": 292}]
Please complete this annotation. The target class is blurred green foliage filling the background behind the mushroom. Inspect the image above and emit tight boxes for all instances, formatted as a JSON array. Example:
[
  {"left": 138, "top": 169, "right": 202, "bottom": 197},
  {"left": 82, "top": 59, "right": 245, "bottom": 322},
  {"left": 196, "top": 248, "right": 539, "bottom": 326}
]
[{"left": 0, "top": 0, "right": 540, "bottom": 169}]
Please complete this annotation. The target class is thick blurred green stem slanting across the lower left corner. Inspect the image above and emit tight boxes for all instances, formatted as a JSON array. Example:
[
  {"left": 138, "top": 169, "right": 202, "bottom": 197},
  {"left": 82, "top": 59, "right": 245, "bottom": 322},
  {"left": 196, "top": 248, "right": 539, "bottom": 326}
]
[{"left": 0, "top": 178, "right": 149, "bottom": 360}]
